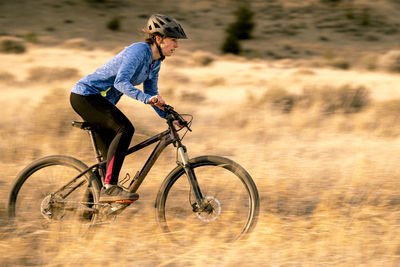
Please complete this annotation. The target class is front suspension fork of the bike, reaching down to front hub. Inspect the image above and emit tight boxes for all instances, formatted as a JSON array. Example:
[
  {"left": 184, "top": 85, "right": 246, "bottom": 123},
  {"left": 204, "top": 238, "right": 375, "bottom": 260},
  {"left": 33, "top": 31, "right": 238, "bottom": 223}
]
[{"left": 178, "top": 145, "right": 203, "bottom": 212}]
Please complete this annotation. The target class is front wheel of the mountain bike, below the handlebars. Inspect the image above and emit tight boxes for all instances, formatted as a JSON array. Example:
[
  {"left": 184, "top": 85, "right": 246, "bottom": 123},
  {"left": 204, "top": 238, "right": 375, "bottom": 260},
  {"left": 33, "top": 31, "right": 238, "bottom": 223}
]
[{"left": 156, "top": 156, "right": 260, "bottom": 243}]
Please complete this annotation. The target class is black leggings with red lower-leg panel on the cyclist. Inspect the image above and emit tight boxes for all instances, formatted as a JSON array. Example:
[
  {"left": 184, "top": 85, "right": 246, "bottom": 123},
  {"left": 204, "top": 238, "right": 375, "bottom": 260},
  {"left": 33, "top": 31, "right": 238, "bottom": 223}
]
[{"left": 70, "top": 93, "right": 135, "bottom": 184}]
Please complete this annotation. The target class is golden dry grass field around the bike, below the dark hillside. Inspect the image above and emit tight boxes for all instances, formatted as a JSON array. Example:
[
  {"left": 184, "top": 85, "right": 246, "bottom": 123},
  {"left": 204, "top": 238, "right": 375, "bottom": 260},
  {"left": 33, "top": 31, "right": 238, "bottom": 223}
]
[{"left": 0, "top": 46, "right": 400, "bottom": 266}]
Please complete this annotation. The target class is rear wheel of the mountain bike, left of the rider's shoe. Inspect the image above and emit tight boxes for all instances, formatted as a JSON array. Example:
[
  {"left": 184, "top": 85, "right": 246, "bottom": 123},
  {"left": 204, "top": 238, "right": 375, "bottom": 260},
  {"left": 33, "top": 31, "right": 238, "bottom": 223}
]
[{"left": 8, "top": 156, "right": 101, "bottom": 232}]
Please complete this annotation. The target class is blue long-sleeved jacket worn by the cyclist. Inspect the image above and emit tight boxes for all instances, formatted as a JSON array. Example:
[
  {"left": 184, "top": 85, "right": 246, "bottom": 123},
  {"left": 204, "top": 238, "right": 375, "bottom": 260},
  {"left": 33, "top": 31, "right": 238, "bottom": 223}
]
[{"left": 71, "top": 42, "right": 165, "bottom": 118}]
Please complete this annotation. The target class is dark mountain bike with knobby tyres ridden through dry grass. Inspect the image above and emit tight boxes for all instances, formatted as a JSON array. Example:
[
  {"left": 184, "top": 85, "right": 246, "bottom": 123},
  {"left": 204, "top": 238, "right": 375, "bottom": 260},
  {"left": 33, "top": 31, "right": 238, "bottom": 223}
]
[{"left": 8, "top": 105, "right": 260, "bottom": 242}]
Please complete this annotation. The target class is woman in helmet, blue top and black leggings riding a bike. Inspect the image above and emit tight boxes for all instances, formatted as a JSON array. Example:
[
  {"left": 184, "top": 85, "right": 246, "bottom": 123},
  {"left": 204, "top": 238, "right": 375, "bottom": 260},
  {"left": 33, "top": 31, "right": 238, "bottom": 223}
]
[{"left": 70, "top": 15, "right": 187, "bottom": 202}]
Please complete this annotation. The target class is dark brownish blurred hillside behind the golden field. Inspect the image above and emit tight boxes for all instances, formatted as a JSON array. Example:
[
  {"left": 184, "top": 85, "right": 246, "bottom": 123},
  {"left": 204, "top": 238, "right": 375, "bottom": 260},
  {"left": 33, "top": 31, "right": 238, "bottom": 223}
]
[{"left": 0, "top": 0, "right": 400, "bottom": 62}]
